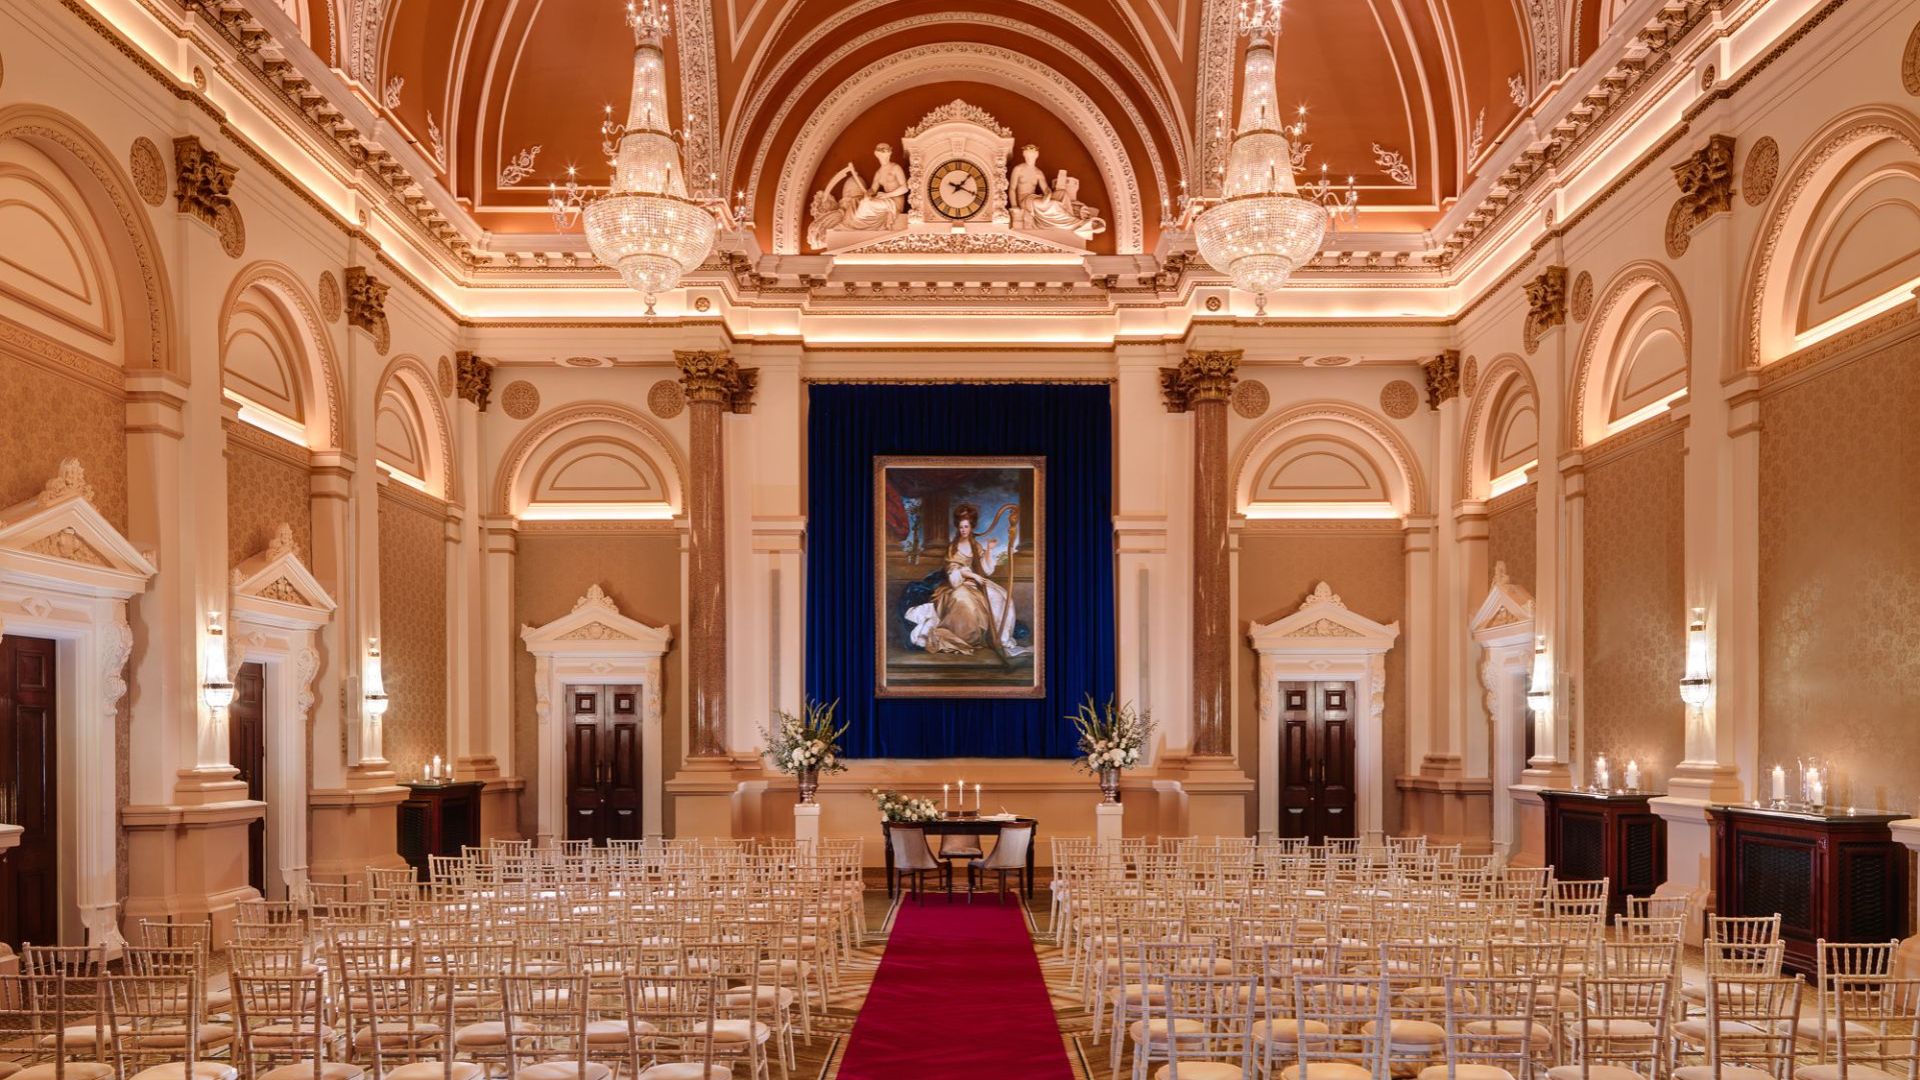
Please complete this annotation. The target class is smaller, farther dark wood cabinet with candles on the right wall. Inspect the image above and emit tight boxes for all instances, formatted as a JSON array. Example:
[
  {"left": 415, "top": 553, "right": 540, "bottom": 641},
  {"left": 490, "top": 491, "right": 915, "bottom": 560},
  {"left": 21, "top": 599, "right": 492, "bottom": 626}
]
[{"left": 1540, "top": 792, "right": 1667, "bottom": 915}]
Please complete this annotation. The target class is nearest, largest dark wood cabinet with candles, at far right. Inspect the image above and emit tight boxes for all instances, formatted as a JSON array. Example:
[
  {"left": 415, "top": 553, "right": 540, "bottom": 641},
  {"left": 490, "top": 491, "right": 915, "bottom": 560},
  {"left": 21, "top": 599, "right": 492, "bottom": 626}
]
[{"left": 1707, "top": 807, "right": 1907, "bottom": 974}]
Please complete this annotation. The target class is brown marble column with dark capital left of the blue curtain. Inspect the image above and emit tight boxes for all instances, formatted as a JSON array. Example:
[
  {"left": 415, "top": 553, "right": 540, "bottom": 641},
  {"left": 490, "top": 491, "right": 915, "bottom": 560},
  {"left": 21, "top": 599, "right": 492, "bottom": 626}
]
[{"left": 674, "top": 350, "right": 758, "bottom": 757}]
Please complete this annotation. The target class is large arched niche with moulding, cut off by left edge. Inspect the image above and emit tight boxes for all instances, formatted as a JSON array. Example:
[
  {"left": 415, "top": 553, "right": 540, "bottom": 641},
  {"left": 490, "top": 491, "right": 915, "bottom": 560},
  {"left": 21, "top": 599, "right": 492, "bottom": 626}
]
[{"left": 0, "top": 104, "right": 184, "bottom": 375}]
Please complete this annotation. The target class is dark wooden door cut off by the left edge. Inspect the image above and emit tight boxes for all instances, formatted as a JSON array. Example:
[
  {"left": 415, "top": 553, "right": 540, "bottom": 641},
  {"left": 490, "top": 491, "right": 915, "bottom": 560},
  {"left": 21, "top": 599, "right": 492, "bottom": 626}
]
[{"left": 0, "top": 634, "right": 60, "bottom": 949}]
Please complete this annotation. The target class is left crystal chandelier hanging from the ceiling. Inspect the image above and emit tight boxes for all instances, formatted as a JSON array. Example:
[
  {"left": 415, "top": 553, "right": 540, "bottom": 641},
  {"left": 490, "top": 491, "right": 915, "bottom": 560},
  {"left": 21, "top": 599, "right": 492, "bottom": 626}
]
[{"left": 549, "top": 0, "right": 732, "bottom": 315}]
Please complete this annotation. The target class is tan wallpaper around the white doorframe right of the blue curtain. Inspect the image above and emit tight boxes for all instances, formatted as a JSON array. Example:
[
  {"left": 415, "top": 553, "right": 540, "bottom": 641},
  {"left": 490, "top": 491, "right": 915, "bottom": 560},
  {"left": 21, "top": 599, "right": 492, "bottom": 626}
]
[{"left": 1233, "top": 530, "right": 1411, "bottom": 832}]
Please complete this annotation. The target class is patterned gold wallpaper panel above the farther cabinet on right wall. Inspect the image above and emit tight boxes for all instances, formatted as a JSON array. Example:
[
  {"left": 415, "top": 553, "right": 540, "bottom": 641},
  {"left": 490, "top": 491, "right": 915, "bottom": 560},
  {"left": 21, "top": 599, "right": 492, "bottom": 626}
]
[{"left": 1576, "top": 429, "right": 1686, "bottom": 792}]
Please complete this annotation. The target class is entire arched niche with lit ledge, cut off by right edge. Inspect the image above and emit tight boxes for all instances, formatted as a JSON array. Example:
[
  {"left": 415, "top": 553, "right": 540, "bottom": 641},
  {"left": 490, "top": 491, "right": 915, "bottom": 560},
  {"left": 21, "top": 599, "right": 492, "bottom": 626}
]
[{"left": 1728, "top": 106, "right": 1920, "bottom": 375}]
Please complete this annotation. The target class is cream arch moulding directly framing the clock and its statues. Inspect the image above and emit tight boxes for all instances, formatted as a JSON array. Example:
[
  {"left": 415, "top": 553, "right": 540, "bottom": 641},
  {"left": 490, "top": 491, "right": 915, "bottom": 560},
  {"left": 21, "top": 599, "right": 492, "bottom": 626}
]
[{"left": 768, "top": 42, "right": 1136, "bottom": 254}]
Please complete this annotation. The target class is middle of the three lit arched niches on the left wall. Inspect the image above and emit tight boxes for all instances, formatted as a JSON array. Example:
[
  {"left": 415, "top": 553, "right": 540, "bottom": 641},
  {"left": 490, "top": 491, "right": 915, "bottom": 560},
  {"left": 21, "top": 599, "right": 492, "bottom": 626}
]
[{"left": 221, "top": 261, "right": 344, "bottom": 450}]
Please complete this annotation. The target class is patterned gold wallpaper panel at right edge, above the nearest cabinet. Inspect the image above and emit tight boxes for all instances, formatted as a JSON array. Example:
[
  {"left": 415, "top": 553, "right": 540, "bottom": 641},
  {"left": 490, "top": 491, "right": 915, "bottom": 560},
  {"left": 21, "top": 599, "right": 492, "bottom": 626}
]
[{"left": 1759, "top": 338, "right": 1920, "bottom": 813}]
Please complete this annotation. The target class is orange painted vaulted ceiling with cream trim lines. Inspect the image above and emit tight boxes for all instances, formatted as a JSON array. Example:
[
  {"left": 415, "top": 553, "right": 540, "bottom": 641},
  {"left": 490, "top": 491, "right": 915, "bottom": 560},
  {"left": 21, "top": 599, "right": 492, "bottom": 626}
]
[{"left": 326, "top": 0, "right": 1559, "bottom": 246}]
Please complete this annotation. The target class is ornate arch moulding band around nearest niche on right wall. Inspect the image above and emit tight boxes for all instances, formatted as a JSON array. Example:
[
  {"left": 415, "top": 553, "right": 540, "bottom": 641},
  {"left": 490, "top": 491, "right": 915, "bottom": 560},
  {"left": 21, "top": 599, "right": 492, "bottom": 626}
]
[{"left": 1722, "top": 106, "right": 1920, "bottom": 368}]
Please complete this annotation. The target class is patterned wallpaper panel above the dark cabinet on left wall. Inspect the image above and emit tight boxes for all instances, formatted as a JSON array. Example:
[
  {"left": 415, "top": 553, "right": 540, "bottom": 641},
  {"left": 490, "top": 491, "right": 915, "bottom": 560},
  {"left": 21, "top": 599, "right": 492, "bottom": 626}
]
[{"left": 380, "top": 484, "right": 447, "bottom": 778}]
